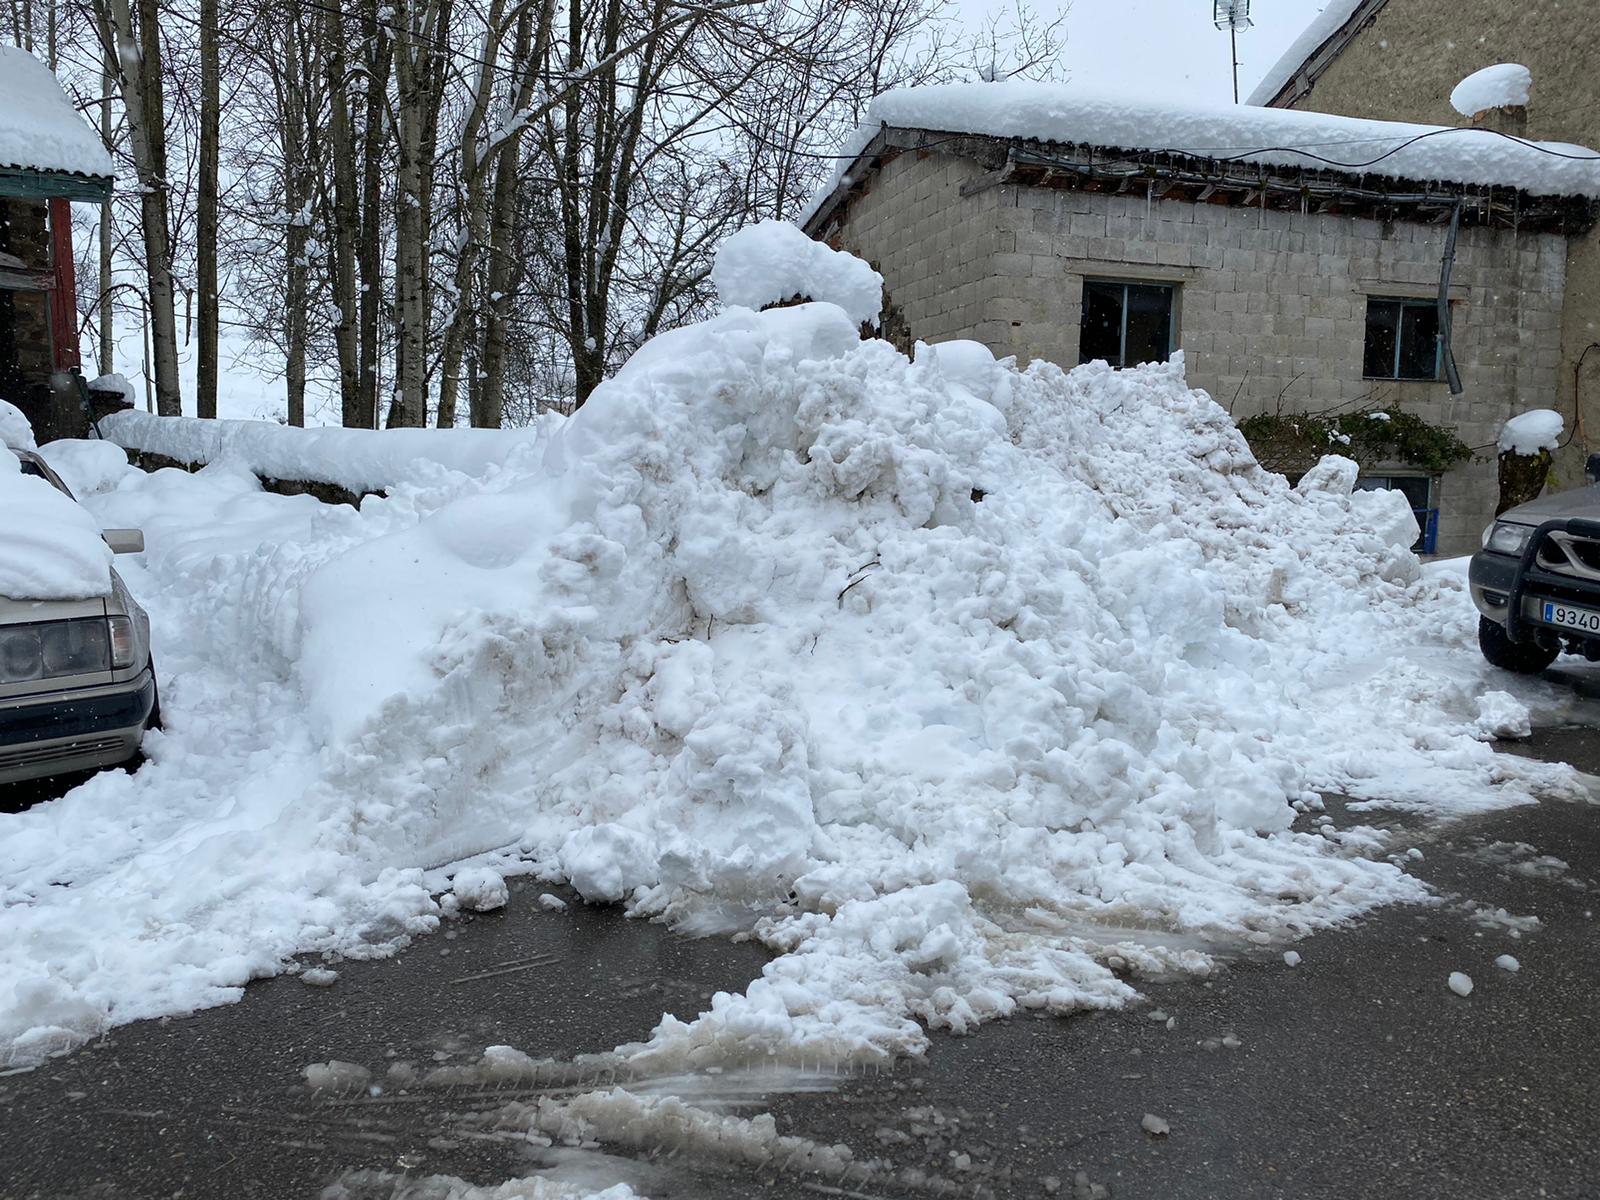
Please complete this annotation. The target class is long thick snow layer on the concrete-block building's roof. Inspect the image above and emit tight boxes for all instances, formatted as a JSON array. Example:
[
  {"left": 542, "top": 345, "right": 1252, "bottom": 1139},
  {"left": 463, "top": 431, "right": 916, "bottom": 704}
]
[{"left": 802, "top": 80, "right": 1600, "bottom": 224}]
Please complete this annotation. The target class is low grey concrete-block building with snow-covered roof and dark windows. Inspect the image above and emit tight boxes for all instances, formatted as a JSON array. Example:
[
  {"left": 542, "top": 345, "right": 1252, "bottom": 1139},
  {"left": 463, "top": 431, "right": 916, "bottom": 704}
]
[{"left": 803, "top": 83, "right": 1600, "bottom": 554}]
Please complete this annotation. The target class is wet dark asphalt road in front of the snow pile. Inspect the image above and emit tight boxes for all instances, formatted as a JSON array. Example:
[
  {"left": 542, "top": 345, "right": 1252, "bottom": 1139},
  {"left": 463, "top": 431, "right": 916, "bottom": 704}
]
[{"left": 0, "top": 728, "right": 1600, "bottom": 1200}]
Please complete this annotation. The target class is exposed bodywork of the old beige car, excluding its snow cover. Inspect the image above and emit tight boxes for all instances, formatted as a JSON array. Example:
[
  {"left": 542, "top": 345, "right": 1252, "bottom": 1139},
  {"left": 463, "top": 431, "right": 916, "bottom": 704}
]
[{"left": 0, "top": 446, "right": 160, "bottom": 784}]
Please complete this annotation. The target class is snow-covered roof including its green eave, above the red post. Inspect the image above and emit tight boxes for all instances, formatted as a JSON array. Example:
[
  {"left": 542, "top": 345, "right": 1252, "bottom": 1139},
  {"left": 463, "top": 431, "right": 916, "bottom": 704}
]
[{"left": 0, "top": 46, "right": 115, "bottom": 202}]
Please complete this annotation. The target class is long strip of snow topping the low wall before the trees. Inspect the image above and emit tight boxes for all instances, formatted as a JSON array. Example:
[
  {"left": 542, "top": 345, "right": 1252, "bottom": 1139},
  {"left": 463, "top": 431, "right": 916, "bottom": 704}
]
[{"left": 99, "top": 410, "right": 550, "bottom": 493}]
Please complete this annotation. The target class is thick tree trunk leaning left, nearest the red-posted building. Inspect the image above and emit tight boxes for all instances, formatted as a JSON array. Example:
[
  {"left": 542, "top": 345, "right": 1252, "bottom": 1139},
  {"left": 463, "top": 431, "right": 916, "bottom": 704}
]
[{"left": 109, "top": 0, "right": 182, "bottom": 416}]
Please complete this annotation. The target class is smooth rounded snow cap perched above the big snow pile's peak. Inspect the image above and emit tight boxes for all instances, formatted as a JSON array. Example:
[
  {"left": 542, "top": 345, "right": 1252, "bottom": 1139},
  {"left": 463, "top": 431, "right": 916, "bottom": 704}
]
[{"left": 710, "top": 221, "right": 883, "bottom": 325}]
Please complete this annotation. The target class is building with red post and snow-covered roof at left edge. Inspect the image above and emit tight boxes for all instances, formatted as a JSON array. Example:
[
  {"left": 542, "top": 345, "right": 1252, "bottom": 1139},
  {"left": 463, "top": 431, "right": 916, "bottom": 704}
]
[{"left": 0, "top": 46, "right": 112, "bottom": 440}]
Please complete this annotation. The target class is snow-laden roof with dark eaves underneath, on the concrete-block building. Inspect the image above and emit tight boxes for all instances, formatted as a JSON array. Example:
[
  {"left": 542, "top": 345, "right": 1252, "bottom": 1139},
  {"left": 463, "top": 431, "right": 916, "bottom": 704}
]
[{"left": 800, "top": 82, "right": 1600, "bottom": 235}]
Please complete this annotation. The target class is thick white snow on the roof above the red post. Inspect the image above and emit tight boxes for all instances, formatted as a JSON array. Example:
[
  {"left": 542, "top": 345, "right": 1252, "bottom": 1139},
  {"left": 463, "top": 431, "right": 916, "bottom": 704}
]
[{"left": 0, "top": 46, "right": 115, "bottom": 179}]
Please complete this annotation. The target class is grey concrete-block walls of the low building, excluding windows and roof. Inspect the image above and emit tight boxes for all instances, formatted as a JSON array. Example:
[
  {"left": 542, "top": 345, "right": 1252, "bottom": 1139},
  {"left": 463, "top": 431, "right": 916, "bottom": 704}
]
[{"left": 819, "top": 155, "right": 1568, "bottom": 554}]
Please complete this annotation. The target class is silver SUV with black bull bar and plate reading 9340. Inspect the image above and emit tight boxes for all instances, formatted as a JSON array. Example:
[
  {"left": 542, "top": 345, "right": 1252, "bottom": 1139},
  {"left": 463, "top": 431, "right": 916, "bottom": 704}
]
[{"left": 1467, "top": 454, "right": 1600, "bottom": 675}]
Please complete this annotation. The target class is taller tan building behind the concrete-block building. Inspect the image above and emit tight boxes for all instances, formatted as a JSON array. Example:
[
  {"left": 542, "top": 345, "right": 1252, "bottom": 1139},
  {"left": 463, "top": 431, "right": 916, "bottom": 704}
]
[{"left": 1250, "top": 0, "right": 1600, "bottom": 518}]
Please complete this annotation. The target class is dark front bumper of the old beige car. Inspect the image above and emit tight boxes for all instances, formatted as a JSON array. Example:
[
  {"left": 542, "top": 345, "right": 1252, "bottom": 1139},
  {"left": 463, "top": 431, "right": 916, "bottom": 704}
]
[{"left": 0, "top": 667, "right": 155, "bottom": 784}]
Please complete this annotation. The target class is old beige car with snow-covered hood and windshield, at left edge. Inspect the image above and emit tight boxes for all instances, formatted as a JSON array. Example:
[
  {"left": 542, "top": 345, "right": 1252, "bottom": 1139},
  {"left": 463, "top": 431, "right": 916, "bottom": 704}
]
[{"left": 0, "top": 448, "right": 160, "bottom": 784}]
